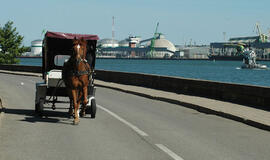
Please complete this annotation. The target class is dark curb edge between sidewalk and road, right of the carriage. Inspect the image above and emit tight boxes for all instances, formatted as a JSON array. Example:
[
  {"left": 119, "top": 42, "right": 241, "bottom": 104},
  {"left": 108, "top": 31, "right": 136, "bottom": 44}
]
[{"left": 96, "top": 84, "right": 270, "bottom": 131}]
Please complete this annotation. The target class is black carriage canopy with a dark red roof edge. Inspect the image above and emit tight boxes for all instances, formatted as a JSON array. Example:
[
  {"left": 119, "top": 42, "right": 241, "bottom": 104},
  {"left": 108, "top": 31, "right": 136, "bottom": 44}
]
[{"left": 42, "top": 31, "right": 99, "bottom": 77}]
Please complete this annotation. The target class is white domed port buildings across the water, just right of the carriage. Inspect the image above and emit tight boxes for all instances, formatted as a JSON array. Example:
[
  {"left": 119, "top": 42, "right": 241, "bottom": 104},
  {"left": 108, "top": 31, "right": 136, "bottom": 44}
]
[{"left": 97, "top": 33, "right": 176, "bottom": 58}]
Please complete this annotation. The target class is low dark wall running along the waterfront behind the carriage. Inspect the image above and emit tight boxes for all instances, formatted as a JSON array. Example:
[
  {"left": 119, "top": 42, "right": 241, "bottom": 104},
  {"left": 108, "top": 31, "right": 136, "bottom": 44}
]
[{"left": 0, "top": 65, "right": 270, "bottom": 110}]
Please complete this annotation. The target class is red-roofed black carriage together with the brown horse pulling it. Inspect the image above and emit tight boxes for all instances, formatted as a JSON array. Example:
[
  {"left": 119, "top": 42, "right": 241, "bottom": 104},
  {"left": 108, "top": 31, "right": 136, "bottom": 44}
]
[{"left": 35, "top": 32, "right": 98, "bottom": 124}]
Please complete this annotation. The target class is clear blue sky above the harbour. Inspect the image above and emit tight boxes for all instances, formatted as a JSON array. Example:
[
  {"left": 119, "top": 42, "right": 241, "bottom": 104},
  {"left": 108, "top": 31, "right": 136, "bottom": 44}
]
[{"left": 0, "top": 0, "right": 270, "bottom": 46}]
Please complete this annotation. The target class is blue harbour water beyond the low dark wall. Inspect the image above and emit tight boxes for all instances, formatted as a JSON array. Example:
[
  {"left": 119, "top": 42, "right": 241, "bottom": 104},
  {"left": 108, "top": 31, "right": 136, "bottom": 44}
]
[{"left": 20, "top": 58, "right": 270, "bottom": 87}]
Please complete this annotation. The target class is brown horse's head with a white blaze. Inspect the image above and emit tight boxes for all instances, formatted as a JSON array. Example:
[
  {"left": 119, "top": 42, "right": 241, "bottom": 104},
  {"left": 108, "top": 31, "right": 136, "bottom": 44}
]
[{"left": 73, "top": 38, "right": 87, "bottom": 59}]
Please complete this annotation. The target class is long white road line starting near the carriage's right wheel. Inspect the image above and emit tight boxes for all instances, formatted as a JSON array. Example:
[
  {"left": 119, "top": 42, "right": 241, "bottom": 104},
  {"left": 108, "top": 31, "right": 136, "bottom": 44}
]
[{"left": 97, "top": 105, "right": 148, "bottom": 137}]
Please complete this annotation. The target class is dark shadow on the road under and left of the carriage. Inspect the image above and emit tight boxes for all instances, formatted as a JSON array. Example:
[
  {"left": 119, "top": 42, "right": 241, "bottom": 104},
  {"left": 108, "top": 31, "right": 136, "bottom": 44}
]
[{"left": 4, "top": 108, "right": 73, "bottom": 124}]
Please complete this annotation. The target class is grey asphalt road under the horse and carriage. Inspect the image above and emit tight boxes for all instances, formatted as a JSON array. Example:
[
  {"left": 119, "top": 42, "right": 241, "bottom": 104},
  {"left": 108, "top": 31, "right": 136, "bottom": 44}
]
[{"left": 0, "top": 73, "right": 270, "bottom": 160}]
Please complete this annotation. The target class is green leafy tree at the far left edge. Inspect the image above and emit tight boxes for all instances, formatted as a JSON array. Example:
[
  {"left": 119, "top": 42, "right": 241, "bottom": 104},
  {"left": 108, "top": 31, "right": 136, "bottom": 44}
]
[{"left": 0, "top": 21, "right": 27, "bottom": 64}]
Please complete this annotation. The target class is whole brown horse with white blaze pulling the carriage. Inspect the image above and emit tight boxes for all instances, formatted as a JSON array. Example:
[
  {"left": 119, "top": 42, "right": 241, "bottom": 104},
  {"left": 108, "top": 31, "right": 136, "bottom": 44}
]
[{"left": 62, "top": 38, "right": 92, "bottom": 124}]
